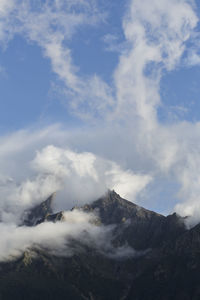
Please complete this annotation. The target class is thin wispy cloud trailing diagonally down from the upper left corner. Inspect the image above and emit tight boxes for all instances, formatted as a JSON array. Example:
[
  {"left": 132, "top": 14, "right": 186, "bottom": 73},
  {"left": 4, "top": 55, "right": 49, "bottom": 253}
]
[{"left": 0, "top": 0, "right": 113, "bottom": 118}]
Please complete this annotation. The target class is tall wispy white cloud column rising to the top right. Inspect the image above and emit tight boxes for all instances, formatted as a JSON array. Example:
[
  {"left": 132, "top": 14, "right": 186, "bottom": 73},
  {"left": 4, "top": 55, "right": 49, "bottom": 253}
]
[{"left": 111, "top": 0, "right": 198, "bottom": 126}]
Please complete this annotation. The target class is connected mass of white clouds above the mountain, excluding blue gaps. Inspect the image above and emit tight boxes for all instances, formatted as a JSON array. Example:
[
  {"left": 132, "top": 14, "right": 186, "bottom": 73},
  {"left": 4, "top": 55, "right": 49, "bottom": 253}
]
[{"left": 0, "top": 0, "right": 200, "bottom": 227}]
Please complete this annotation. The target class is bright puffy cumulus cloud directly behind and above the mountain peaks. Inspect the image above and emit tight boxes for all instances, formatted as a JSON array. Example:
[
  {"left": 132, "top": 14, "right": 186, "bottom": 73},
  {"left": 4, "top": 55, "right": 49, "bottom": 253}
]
[{"left": 0, "top": 131, "right": 152, "bottom": 222}]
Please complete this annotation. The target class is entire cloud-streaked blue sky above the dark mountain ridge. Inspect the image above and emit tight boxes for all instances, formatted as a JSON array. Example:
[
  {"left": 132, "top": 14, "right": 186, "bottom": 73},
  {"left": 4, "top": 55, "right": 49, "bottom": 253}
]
[{"left": 0, "top": 0, "right": 200, "bottom": 223}]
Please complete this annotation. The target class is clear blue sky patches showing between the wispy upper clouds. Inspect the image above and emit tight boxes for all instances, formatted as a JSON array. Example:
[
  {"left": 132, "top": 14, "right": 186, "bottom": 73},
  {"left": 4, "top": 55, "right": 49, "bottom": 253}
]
[{"left": 0, "top": 1, "right": 200, "bottom": 133}]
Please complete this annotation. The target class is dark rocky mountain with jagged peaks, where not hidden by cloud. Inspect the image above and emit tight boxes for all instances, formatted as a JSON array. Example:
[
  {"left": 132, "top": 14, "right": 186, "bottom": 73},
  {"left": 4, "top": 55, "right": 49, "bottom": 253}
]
[{"left": 0, "top": 191, "right": 200, "bottom": 300}]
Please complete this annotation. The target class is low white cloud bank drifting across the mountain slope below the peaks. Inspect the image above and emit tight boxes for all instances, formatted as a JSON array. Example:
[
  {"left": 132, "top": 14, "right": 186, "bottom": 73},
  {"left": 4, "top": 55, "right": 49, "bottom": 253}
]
[{"left": 0, "top": 210, "right": 140, "bottom": 261}]
